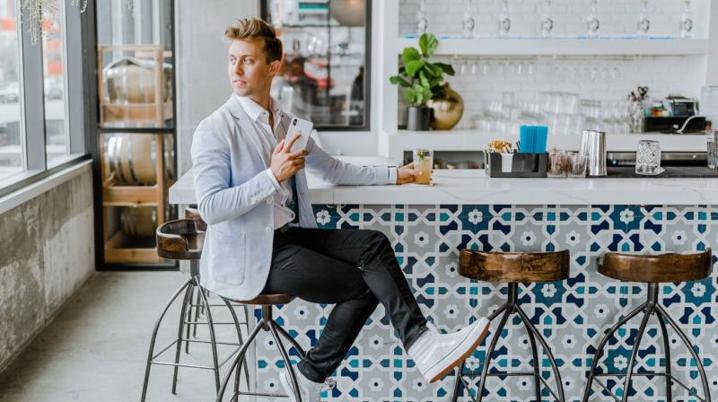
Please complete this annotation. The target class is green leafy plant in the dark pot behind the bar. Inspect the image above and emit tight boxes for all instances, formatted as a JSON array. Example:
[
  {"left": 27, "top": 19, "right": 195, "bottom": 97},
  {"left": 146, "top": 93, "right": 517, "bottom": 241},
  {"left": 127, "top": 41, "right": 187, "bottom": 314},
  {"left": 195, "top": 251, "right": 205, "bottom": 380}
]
[{"left": 389, "top": 33, "right": 454, "bottom": 107}]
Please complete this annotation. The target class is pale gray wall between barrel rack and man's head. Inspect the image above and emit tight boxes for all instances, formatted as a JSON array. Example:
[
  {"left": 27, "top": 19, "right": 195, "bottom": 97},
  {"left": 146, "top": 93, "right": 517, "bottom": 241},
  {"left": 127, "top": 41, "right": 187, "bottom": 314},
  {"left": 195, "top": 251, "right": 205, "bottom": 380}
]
[{"left": 175, "top": 0, "right": 259, "bottom": 175}]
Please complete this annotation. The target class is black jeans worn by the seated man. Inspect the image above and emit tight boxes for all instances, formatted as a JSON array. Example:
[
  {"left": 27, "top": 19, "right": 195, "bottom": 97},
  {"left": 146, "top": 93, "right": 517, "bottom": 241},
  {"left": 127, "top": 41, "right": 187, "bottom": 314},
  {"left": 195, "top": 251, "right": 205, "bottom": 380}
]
[{"left": 262, "top": 228, "right": 426, "bottom": 382}]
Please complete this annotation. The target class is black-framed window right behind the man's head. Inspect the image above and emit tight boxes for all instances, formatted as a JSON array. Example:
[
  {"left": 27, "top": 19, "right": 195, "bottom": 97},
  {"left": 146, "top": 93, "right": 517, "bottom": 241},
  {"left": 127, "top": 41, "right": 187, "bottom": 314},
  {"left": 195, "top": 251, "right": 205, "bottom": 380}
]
[{"left": 262, "top": 0, "right": 371, "bottom": 130}]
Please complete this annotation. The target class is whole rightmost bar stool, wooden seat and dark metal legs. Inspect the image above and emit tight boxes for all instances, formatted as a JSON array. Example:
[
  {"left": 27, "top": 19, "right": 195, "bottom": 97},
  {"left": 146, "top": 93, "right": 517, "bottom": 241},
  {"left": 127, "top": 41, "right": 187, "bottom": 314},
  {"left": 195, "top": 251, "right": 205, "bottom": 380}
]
[{"left": 583, "top": 249, "right": 713, "bottom": 402}]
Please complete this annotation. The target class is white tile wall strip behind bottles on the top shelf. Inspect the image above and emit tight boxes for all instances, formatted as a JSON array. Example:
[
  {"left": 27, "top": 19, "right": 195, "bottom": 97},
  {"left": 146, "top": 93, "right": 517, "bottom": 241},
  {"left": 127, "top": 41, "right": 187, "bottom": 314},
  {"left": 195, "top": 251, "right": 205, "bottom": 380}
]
[{"left": 399, "top": 0, "right": 709, "bottom": 38}]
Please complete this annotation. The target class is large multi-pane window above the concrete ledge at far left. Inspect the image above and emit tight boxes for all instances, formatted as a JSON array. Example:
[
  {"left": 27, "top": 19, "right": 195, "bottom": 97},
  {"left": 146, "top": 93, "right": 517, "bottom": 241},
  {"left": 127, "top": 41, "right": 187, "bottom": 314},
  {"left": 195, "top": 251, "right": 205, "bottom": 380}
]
[{"left": 0, "top": 0, "right": 88, "bottom": 197}]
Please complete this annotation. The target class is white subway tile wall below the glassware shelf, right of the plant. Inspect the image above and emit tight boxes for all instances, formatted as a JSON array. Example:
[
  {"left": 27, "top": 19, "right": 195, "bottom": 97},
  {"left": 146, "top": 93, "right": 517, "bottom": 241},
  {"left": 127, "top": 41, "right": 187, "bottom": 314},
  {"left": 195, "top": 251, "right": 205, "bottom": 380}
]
[{"left": 436, "top": 56, "right": 705, "bottom": 128}]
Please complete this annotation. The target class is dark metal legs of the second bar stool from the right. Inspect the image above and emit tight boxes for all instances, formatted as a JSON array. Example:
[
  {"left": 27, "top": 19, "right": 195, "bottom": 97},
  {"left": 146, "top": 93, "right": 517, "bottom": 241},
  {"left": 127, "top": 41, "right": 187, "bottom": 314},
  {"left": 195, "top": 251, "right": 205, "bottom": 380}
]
[{"left": 451, "top": 283, "right": 566, "bottom": 402}]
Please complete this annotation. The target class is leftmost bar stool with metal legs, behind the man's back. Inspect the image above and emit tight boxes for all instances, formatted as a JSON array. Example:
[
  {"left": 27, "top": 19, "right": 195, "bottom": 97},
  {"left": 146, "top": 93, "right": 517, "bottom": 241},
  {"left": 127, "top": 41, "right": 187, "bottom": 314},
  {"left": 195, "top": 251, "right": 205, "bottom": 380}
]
[{"left": 141, "top": 215, "right": 249, "bottom": 402}]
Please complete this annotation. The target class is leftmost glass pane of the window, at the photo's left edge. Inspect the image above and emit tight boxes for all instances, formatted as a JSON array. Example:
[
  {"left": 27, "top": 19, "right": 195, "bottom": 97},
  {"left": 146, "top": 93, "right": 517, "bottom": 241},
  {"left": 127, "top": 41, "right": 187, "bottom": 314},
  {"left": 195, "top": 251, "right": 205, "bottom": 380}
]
[{"left": 0, "top": 0, "right": 25, "bottom": 182}]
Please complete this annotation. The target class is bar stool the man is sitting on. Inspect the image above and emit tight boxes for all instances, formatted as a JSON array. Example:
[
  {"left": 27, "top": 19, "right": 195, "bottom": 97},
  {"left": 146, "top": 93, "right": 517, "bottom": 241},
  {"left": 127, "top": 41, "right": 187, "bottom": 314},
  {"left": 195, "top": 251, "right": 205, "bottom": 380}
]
[{"left": 217, "top": 293, "right": 304, "bottom": 402}]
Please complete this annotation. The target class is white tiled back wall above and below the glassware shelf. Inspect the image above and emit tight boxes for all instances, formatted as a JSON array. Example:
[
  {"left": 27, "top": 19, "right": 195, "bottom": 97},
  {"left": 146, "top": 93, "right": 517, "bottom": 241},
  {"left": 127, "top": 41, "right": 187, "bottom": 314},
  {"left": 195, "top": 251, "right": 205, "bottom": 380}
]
[{"left": 399, "top": 0, "right": 707, "bottom": 129}]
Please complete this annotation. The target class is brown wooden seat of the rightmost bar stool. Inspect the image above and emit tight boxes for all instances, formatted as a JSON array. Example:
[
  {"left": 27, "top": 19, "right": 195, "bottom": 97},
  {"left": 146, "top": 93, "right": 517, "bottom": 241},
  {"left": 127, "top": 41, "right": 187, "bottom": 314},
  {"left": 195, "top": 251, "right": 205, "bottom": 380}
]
[{"left": 598, "top": 249, "right": 713, "bottom": 283}]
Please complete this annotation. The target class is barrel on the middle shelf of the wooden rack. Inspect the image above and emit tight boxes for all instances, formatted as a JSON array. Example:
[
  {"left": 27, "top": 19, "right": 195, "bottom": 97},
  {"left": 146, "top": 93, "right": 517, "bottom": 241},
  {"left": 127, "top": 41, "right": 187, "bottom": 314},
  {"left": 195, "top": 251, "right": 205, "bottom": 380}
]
[{"left": 105, "top": 134, "right": 175, "bottom": 186}]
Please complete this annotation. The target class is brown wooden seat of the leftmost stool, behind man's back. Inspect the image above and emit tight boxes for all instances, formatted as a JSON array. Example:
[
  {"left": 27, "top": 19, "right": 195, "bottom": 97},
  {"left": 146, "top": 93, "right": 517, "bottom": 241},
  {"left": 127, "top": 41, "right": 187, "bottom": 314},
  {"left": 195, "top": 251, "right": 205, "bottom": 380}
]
[{"left": 156, "top": 219, "right": 205, "bottom": 260}]
